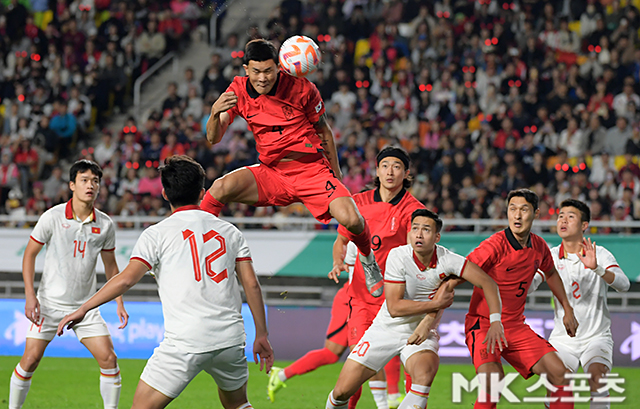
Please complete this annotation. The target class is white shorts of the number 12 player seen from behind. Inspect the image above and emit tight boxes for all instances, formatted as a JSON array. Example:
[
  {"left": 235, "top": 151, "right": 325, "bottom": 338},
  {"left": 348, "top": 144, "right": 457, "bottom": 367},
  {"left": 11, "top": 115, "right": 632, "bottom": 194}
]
[{"left": 140, "top": 339, "right": 249, "bottom": 398}]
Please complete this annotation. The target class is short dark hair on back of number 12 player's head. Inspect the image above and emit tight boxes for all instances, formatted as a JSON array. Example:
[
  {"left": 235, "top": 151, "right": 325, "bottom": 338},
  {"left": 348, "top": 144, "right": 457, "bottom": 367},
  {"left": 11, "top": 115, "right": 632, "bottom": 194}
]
[{"left": 158, "top": 155, "right": 205, "bottom": 208}]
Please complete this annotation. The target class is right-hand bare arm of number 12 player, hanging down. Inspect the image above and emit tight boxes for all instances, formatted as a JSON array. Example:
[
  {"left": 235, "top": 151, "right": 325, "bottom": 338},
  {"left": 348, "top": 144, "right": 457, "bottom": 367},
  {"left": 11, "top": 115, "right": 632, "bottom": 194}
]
[{"left": 236, "top": 261, "right": 273, "bottom": 373}]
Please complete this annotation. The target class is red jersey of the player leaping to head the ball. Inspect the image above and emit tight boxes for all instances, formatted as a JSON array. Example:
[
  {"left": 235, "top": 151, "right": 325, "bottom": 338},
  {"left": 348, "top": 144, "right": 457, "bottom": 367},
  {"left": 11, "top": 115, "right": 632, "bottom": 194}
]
[{"left": 227, "top": 72, "right": 324, "bottom": 165}]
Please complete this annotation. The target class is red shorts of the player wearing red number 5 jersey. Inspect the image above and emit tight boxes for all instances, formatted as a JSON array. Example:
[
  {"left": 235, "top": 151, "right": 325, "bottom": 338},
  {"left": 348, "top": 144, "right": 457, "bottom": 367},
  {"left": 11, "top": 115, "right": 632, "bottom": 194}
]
[{"left": 465, "top": 316, "right": 555, "bottom": 379}]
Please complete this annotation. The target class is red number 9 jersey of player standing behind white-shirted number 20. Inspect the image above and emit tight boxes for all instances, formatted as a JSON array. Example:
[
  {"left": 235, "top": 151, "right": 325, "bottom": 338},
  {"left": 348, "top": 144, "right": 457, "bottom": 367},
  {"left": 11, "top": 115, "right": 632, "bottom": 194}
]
[{"left": 338, "top": 189, "right": 424, "bottom": 305}]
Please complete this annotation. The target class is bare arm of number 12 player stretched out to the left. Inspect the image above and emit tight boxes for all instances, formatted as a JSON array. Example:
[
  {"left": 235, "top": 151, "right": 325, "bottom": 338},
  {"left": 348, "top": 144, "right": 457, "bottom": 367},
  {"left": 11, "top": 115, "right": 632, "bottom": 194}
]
[{"left": 58, "top": 260, "right": 149, "bottom": 335}]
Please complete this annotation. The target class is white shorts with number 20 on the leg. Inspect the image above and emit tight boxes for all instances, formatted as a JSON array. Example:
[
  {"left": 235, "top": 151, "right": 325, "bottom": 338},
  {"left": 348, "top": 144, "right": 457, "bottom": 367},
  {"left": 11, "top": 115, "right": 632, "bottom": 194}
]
[{"left": 348, "top": 322, "right": 440, "bottom": 372}]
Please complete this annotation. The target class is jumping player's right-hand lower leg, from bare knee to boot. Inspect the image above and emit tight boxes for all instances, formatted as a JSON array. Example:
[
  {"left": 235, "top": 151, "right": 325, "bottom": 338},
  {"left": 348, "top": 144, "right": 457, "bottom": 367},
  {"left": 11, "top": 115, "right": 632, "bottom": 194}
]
[{"left": 329, "top": 197, "right": 384, "bottom": 297}]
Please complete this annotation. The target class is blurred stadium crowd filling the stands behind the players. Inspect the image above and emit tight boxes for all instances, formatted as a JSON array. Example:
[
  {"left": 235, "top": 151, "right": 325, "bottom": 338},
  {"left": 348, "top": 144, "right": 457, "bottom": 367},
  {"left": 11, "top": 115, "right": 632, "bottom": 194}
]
[{"left": 0, "top": 0, "right": 640, "bottom": 233}]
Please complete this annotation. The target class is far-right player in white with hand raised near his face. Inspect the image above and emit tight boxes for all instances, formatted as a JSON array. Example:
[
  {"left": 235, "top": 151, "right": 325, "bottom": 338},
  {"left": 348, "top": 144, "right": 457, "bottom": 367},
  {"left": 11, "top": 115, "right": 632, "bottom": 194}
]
[{"left": 529, "top": 199, "right": 630, "bottom": 409}]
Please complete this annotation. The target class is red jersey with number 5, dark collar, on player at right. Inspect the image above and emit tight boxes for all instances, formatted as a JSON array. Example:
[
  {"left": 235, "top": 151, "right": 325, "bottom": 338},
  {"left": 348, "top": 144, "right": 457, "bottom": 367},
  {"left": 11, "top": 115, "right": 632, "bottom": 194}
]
[{"left": 467, "top": 228, "right": 554, "bottom": 324}]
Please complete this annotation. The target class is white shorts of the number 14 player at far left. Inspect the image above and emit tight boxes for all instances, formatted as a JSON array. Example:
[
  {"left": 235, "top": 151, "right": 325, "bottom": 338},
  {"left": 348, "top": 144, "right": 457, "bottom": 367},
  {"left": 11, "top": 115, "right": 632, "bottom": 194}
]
[{"left": 27, "top": 304, "right": 109, "bottom": 341}]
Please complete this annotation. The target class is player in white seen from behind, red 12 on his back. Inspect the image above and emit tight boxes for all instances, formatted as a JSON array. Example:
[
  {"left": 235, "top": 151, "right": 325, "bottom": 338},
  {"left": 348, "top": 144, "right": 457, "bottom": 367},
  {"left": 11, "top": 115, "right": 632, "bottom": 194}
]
[{"left": 58, "top": 156, "right": 273, "bottom": 409}]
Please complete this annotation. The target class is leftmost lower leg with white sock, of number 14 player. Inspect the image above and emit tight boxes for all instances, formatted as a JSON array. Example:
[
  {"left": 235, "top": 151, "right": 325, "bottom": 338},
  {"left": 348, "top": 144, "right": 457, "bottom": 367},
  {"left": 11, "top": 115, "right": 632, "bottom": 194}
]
[{"left": 9, "top": 338, "right": 49, "bottom": 409}]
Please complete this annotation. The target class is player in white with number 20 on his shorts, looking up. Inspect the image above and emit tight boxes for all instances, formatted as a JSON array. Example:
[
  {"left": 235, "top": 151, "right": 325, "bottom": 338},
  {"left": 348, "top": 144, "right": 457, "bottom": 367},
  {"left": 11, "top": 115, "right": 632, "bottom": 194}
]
[{"left": 326, "top": 209, "right": 506, "bottom": 409}]
